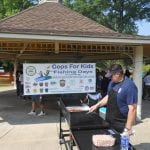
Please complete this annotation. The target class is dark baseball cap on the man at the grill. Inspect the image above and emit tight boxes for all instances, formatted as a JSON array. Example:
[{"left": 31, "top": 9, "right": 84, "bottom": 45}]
[{"left": 105, "top": 64, "right": 123, "bottom": 78}]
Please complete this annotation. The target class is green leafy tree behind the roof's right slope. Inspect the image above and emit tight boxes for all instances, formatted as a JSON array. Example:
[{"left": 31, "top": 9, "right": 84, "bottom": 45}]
[{"left": 65, "top": 0, "right": 150, "bottom": 34}]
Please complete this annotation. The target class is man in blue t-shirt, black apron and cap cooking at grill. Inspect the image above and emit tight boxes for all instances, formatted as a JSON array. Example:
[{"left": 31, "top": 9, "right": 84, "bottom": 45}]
[{"left": 90, "top": 64, "right": 138, "bottom": 134}]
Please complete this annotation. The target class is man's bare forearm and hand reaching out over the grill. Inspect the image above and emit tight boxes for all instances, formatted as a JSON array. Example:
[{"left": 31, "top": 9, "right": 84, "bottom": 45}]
[{"left": 89, "top": 95, "right": 108, "bottom": 112}]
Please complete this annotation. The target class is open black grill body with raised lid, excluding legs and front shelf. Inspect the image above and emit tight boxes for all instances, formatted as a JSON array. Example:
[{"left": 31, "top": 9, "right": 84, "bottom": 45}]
[{"left": 59, "top": 95, "right": 109, "bottom": 130}]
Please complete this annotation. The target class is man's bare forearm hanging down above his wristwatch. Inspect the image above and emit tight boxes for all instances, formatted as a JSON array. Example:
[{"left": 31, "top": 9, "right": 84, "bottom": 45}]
[{"left": 125, "top": 104, "right": 137, "bottom": 130}]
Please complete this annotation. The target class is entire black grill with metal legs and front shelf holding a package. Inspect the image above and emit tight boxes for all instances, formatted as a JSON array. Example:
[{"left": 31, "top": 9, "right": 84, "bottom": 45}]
[{"left": 58, "top": 96, "right": 135, "bottom": 150}]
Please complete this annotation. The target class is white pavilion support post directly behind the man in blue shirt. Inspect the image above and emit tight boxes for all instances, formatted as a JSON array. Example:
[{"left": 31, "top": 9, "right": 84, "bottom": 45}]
[{"left": 133, "top": 46, "right": 143, "bottom": 120}]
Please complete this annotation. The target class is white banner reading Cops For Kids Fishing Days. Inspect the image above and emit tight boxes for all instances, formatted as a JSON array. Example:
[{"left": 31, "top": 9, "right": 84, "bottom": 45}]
[{"left": 23, "top": 63, "right": 96, "bottom": 95}]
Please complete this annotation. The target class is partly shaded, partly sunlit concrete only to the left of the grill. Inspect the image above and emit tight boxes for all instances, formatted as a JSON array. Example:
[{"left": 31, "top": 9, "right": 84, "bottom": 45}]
[{"left": 0, "top": 90, "right": 60, "bottom": 150}]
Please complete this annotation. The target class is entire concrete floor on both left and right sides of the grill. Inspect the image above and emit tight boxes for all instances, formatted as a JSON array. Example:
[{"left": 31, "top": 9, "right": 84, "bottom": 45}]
[{"left": 0, "top": 90, "right": 150, "bottom": 150}]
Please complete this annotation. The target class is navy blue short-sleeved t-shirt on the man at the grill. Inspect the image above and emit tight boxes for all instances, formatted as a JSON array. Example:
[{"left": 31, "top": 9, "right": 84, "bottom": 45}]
[{"left": 108, "top": 77, "right": 138, "bottom": 116}]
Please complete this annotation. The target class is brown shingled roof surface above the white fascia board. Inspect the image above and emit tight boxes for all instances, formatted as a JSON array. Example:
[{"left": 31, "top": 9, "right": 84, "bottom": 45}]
[{"left": 0, "top": 2, "right": 149, "bottom": 39}]
